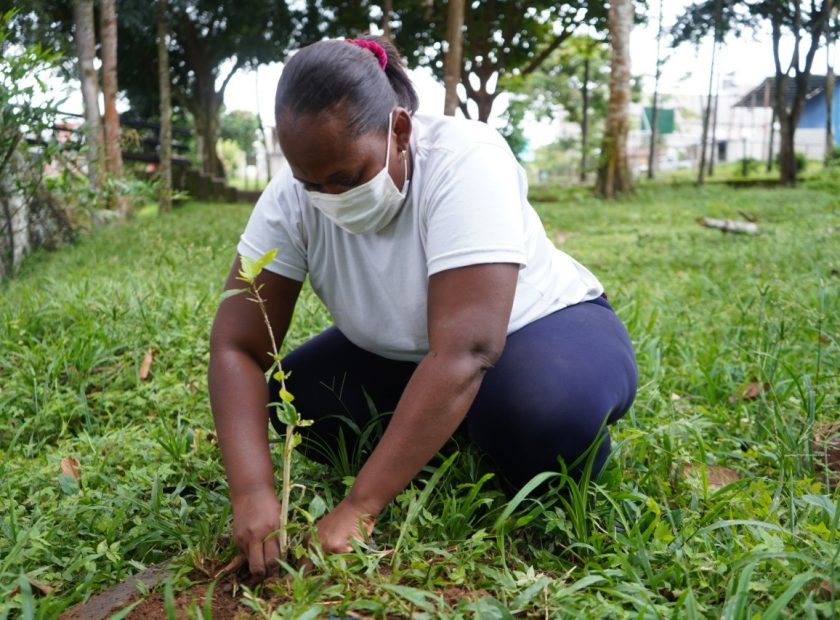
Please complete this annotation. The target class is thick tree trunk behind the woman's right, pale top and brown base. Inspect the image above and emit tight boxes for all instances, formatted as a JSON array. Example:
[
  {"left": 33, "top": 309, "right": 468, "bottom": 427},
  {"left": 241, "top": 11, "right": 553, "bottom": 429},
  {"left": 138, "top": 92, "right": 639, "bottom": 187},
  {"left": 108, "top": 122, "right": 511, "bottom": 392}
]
[{"left": 597, "top": 0, "right": 633, "bottom": 199}]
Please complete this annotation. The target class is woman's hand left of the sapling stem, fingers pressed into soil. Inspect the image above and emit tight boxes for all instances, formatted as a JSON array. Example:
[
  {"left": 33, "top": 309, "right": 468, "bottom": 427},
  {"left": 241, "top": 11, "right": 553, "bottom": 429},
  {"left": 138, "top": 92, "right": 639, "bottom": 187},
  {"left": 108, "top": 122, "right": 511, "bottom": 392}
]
[{"left": 233, "top": 488, "right": 280, "bottom": 580}]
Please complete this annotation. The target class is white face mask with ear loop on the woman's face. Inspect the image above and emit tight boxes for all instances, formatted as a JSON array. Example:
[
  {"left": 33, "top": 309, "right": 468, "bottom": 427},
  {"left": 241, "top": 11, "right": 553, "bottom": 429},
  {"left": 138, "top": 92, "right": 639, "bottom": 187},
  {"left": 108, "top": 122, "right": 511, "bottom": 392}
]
[{"left": 306, "top": 111, "right": 408, "bottom": 234}]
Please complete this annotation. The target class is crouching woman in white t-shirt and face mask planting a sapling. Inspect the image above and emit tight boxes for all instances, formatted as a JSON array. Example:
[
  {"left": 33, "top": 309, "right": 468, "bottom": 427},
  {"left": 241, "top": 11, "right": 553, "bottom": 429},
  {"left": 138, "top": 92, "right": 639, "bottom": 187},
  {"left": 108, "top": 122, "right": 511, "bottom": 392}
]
[{"left": 209, "top": 37, "right": 636, "bottom": 576}]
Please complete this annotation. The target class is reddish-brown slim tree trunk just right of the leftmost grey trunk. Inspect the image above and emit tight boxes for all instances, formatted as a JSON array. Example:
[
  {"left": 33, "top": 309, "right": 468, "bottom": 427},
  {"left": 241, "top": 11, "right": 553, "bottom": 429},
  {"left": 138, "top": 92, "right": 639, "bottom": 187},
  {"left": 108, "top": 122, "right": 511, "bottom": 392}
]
[{"left": 99, "top": 0, "right": 129, "bottom": 219}]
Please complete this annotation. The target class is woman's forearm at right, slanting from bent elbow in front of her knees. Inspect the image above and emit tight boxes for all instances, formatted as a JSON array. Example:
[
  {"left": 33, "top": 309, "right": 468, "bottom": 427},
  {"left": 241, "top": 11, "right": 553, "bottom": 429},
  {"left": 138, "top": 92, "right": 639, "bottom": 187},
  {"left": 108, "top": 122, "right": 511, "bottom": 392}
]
[{"left": 348, "top": 351, "right": 488, "bottom": 517}]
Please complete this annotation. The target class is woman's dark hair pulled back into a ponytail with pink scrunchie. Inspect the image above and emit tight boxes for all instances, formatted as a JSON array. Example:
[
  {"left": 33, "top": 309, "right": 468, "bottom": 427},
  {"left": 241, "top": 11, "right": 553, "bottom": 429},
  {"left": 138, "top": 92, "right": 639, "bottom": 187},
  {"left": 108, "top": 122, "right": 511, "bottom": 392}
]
[{"left": 274, "top": 36, "right": 419, "bottom": 136}]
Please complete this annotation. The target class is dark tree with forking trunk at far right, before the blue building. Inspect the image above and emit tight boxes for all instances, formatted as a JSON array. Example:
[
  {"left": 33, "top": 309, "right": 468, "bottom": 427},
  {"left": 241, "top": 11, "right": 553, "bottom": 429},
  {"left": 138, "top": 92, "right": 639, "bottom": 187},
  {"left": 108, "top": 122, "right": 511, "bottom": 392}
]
[{"left": 673, "top": 0, "right": 836, "bottom": 185}]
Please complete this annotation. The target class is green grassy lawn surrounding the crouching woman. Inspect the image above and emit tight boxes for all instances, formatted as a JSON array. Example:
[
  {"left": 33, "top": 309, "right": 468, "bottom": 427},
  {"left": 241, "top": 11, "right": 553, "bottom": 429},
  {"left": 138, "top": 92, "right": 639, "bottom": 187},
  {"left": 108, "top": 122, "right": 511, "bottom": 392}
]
[{"left": 0, "top": 181, "right": 840, "bottom": 618}]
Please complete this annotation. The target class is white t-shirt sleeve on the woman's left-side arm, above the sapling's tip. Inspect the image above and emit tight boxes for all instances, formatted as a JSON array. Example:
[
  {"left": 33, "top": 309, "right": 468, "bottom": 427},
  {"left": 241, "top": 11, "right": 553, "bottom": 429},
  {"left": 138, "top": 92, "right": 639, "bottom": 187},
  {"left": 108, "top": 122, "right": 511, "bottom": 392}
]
[{"left": 236, "top": 166, "right": 308, "bottom": 282}]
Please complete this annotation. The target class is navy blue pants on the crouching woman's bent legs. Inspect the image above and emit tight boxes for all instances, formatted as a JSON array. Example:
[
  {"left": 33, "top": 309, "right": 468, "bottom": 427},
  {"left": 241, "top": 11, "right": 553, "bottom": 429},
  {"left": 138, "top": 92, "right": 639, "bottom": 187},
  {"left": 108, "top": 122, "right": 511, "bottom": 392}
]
[{"left": 270, "top": 298, "right": 637, "bottom": 487}]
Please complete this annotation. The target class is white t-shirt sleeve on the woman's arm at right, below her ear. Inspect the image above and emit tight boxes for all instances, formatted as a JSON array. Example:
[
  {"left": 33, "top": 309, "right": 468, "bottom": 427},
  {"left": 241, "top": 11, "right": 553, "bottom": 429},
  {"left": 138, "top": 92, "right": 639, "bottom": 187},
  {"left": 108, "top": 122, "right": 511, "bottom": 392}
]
[{"left": 424, "top": 143, "right": 526, "bottom": 276}]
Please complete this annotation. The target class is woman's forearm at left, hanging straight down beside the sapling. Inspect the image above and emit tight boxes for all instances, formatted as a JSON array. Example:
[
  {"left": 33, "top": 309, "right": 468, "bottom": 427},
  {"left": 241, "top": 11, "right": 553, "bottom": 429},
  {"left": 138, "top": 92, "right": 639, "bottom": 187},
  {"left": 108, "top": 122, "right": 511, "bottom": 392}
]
[{"left": 208, "top": 349, "right": 274, "bottom": 499}]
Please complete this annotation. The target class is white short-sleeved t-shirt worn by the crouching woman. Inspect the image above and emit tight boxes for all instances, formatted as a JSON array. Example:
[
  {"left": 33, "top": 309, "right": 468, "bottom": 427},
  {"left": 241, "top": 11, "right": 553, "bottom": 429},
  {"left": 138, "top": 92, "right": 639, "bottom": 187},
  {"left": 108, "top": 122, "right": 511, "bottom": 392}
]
[{"left": 237, "top": 114, "right": 603, "bottom": 361}]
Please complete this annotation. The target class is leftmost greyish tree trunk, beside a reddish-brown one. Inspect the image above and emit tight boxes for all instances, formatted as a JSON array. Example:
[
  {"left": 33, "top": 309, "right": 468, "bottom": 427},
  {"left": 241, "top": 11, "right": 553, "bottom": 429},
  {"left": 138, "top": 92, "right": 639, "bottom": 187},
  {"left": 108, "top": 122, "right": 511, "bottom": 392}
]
[{"left": 73, "top": 0, "right": 102, "bottom": 188}]
